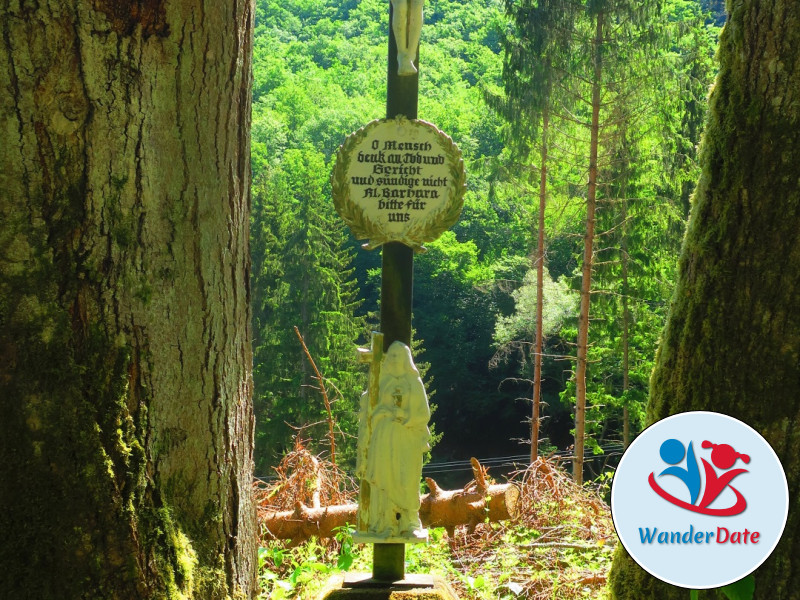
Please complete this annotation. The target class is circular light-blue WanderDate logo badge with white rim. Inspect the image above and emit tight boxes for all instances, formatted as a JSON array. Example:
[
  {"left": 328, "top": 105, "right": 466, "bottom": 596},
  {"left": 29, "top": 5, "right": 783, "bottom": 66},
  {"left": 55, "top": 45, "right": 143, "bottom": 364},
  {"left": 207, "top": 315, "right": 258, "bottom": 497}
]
[{"left": 611, "top": 412, "right": 789, "bottom": 589}]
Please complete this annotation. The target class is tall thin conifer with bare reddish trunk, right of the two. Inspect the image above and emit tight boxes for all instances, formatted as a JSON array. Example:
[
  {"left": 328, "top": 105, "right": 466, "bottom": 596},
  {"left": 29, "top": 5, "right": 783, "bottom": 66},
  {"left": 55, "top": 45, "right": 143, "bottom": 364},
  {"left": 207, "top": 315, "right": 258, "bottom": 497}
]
[{"left": 528, "top": 0, "right": 657, "bottom": 482}]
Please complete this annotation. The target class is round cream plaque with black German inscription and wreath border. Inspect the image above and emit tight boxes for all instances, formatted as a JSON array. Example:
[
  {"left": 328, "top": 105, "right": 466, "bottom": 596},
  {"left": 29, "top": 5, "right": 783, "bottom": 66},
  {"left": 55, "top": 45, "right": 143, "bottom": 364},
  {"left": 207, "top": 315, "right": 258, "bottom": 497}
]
[{"left": 331, "top": 116, "right": 466, "bottom": 251}]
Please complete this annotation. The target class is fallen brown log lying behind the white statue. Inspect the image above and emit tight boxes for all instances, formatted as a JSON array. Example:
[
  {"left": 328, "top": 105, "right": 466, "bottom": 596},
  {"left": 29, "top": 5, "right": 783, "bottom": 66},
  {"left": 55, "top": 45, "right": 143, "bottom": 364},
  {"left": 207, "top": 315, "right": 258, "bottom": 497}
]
[{"left": 259, "top": 459, "right": 520, "bottom": 543}]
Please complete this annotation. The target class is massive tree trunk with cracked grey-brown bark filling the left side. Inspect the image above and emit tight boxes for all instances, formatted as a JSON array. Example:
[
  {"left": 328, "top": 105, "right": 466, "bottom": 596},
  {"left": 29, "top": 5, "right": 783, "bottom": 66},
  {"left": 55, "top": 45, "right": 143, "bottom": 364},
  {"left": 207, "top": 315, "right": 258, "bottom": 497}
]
[{"left": 0, "top": 0, "right": 255, "bottom": 600}]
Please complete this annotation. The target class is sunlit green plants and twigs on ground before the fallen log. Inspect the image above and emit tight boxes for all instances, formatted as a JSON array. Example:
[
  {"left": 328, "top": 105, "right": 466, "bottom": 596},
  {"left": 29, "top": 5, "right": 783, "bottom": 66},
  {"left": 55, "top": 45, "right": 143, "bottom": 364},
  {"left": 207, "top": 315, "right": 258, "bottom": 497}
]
[{"left": 259, "top": 499, "right": 616, "bottom": 600}]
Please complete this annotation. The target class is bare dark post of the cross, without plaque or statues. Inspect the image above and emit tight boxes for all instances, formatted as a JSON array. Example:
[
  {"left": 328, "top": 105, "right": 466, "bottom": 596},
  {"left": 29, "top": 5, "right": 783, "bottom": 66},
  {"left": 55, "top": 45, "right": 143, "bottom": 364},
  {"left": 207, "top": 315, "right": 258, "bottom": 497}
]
[{"left": 372, "top": 3, "right": 419, "bottom": 581}]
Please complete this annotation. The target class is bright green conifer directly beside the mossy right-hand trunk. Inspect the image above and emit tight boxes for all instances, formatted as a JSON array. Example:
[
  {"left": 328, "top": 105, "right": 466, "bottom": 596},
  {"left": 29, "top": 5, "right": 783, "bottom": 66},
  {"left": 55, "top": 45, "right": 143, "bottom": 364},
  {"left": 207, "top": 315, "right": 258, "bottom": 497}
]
[{"left": 587, "top": 2, "right": 714, "bottom": 445}]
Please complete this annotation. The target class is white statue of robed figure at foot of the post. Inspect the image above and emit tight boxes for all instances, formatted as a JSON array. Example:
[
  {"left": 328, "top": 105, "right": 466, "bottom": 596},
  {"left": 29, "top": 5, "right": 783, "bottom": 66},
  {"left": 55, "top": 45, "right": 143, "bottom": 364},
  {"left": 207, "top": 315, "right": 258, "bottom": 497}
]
[{"left": 360, "top": 341, "right": 431, "bottom": 541}]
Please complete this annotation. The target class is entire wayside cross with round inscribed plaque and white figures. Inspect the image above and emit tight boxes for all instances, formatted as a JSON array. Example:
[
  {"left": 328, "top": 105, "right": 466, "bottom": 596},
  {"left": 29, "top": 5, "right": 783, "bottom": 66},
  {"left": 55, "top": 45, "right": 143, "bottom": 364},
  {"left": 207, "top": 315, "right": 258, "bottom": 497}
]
[{"left": 331, "top": 0, "right": 466, "bottom": 583}]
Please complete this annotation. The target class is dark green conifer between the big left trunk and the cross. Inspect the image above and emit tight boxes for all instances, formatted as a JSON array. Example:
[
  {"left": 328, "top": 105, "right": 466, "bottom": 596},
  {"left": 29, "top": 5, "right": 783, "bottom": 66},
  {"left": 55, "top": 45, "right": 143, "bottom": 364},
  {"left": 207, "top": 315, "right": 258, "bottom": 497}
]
[{"left": 253, "top": 148, "right": 364, "bottom": 470}]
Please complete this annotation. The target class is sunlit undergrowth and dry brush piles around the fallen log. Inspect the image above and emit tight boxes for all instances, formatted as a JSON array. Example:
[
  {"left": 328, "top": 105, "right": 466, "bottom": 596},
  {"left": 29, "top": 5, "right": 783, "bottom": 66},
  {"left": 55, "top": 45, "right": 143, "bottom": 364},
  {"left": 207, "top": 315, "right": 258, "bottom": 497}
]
[{"left": 256, "top": 447, "right": 617, "bottom": 600}]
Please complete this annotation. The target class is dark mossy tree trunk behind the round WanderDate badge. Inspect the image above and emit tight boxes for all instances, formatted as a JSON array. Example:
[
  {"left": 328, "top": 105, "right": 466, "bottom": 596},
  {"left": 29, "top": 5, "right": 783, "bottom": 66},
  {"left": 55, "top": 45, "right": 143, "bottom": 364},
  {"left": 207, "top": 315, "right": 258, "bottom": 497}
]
[{"left": 610, "top": 0, "right": 800, "bottom": 600}]
